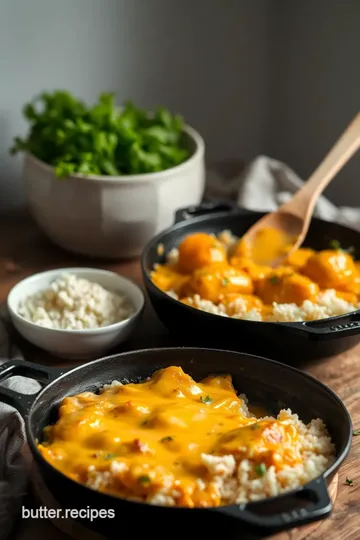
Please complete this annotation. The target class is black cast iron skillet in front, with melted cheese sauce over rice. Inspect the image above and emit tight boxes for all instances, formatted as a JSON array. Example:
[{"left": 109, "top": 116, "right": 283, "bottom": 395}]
[{"left": 0, "top": 348, "right": 352, "bottom": 540}]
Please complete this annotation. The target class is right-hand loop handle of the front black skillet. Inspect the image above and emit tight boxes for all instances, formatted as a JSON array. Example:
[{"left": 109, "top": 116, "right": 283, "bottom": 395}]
[{"left": 212, "top": 477, "right": 332, "bottom": 537}]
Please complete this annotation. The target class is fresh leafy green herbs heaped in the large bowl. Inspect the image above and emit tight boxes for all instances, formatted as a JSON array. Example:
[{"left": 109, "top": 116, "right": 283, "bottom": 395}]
[{"left": 10, "top": 90, "right": 190, "bottom": 177}]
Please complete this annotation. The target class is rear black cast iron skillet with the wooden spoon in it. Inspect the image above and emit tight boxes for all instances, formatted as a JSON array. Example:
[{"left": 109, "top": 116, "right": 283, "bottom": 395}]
[{"left": 141, "top": 203, "right": 360, "bottom": 363}]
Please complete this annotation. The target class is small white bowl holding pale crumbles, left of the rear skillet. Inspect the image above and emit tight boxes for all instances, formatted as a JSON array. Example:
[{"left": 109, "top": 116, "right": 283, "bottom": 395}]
[{"left": 7, "top": 268, "right": 145, "bottom": 360}]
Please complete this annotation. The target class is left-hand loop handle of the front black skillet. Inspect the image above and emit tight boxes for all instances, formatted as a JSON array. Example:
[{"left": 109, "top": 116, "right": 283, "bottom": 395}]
[{"left": 0, "top": 360, "right": 65, "bottom": 418}]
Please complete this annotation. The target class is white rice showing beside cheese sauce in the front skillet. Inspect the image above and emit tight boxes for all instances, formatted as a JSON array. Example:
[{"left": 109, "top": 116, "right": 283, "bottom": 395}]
[{"left": 87, "top": 400, "right": 335, "bottom": 506}]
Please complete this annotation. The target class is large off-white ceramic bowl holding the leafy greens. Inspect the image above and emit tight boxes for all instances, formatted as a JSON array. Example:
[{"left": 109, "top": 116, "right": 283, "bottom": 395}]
[{"left": 23, "top": 127, "right": 205, "bottom": 259}]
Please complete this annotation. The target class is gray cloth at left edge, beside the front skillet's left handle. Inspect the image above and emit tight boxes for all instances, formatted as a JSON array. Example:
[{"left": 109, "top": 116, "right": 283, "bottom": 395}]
[{"left": 0, "top": 313, "right": 41, "bottom": 540}]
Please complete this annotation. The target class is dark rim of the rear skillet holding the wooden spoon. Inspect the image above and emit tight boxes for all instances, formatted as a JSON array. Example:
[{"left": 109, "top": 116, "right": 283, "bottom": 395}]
[{"left": 140, "top": 207, "right": 360, "bottom": 328}]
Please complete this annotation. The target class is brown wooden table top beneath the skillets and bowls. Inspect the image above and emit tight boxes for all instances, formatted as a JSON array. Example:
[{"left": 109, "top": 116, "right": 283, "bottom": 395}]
[{"left": 0, "top": 216, "right": 360, "bottom": 540}]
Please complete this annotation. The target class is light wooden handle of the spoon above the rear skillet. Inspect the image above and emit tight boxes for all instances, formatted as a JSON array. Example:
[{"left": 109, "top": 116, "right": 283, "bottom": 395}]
[{"left": 281, "top": 113, "right": 360, "bottom": 221}]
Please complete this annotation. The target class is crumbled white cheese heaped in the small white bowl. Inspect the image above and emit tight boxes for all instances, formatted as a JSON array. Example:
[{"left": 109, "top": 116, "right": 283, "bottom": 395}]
[{"left": 18, "top": 274, "right": 133, "bottom": 330}]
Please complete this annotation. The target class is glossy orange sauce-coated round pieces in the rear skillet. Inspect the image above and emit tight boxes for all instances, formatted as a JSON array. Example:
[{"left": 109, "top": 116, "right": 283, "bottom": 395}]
[{"left": 151, "top": 229, "right": 360, "bottom": 320}]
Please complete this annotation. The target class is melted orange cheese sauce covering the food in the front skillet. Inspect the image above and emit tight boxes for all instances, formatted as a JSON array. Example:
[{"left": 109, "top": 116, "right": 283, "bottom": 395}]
[{"left": 38, "top": 366, "right": 300, "bottom": 507}]
